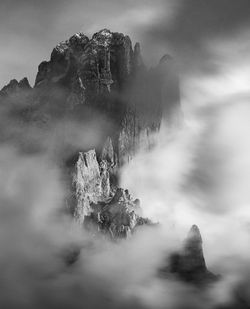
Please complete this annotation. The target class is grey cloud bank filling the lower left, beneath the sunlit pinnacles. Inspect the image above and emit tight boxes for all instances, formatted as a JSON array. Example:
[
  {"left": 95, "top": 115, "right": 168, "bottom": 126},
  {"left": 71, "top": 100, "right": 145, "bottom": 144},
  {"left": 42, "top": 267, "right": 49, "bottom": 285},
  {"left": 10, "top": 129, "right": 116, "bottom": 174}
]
[{"left": 0, "top": 147, "right": 196, "bottom": 309}]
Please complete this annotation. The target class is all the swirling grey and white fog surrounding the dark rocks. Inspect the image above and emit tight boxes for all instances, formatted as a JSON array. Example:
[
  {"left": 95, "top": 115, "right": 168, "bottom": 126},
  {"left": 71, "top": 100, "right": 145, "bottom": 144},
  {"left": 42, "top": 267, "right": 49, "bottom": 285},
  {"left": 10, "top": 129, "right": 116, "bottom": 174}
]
[{"left": 0, "top": 0, "right": 250, "bottom": 309}]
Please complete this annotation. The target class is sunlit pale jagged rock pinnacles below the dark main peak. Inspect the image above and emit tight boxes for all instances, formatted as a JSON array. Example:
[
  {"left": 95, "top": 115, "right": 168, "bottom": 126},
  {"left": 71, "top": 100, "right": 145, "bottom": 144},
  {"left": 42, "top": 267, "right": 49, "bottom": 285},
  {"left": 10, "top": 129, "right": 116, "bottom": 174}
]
[{"left": 73, "top": 147, "right": 152, "bottom": 239}]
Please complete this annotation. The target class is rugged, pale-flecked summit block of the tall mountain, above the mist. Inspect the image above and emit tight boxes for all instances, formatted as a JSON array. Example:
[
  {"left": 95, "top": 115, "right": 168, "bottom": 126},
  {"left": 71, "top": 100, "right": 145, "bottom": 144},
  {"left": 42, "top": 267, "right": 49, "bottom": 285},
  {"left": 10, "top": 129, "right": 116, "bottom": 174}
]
[{"left": 35, "top": 29, "right": 135, "bottom": 100}]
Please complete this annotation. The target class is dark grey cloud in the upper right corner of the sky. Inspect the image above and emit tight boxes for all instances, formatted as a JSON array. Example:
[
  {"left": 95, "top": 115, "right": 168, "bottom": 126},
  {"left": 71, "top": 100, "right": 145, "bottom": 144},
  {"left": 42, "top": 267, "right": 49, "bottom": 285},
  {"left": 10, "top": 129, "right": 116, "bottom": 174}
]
[{"left": 145, "top": 0, "right": 250, "bottom": 74}]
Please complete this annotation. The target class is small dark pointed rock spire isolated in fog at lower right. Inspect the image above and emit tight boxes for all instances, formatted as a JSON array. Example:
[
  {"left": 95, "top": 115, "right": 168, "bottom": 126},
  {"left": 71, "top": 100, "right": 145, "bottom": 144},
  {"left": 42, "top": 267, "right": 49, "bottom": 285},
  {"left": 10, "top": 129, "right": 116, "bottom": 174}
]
[{"left": 160, "top": 225, "right": 219, "bottom": 285}]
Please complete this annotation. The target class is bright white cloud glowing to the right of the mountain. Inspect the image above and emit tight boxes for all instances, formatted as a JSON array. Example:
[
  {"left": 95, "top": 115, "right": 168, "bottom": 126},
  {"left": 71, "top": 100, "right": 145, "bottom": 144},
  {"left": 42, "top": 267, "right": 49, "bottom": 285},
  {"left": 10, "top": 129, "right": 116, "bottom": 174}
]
[{"left": 122, "top": 79, "right": 250, "bottom": 308}]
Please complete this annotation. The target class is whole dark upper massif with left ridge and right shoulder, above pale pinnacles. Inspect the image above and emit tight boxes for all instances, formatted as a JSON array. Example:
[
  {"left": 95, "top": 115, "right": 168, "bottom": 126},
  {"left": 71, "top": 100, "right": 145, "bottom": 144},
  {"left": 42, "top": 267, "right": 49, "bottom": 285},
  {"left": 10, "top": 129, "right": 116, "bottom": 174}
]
[{"left": 0, "top": 29, "right": 180, "bottom": 166}]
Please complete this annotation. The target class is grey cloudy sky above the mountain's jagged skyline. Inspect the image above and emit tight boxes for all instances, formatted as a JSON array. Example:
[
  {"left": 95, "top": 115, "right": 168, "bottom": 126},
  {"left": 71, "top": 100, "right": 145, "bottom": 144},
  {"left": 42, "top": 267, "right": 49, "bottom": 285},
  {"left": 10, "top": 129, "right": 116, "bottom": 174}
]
[{"left": 0, "top": 0, "right": 250, "bottom": 87}]
